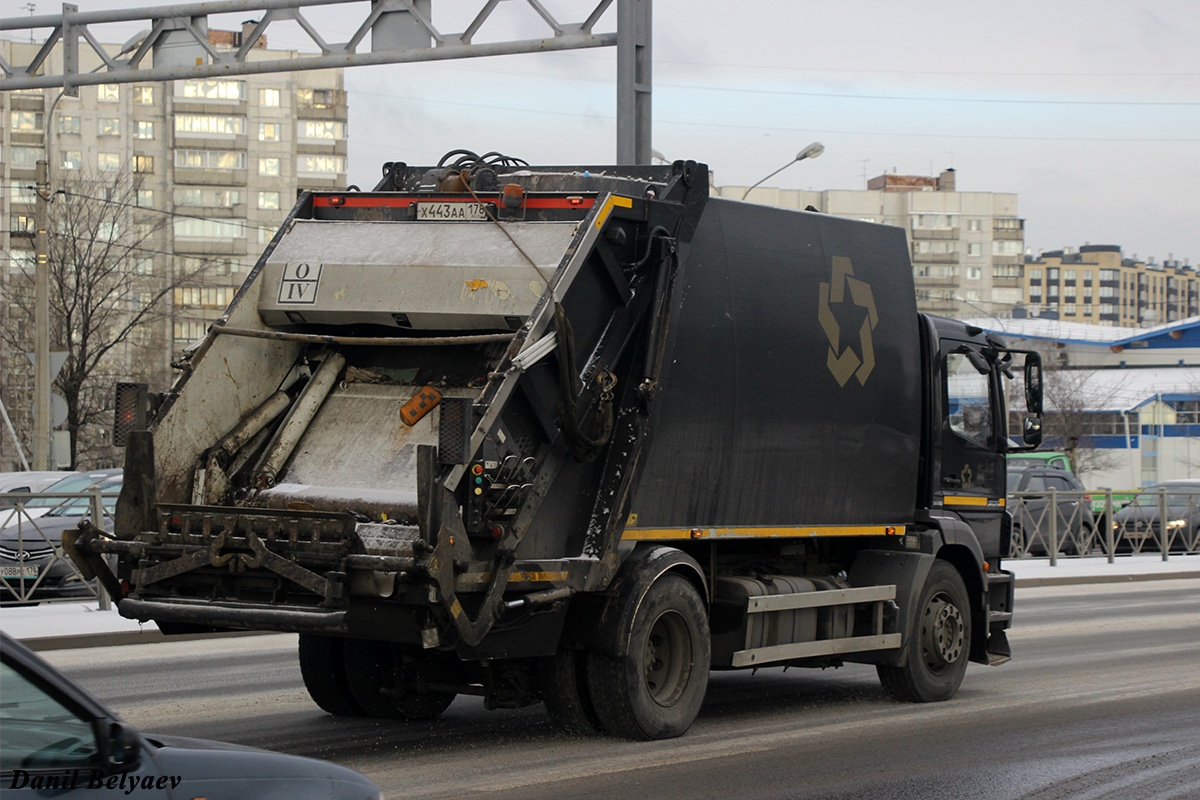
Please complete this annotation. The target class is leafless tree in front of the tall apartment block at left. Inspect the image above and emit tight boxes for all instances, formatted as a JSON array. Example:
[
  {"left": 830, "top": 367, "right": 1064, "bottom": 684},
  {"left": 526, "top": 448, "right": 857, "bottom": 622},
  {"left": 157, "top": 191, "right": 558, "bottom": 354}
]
[{"left": 2, "top": 166, "right": 196, "bottom": 469}]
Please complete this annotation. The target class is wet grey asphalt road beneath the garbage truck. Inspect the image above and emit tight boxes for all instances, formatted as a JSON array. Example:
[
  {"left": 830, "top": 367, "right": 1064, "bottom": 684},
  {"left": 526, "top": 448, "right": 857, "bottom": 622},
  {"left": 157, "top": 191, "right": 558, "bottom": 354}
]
[{"left": 42, "top": 579, "right": 1200, "bottom": 800}]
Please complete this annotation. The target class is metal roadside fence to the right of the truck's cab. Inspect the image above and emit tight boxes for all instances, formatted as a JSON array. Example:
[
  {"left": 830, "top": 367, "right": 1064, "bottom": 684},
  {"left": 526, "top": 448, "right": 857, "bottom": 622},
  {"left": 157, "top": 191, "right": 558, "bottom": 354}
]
[{"left": 1008, "top": 489, "right": 1200, "bottom": 566}]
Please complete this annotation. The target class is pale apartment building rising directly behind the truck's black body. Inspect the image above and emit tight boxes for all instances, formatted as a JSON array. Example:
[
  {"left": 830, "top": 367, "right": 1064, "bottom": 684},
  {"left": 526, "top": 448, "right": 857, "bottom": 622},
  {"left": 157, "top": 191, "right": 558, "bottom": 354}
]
[{"left": 714, "top": 169, "right": 1025, "bottom": 317}]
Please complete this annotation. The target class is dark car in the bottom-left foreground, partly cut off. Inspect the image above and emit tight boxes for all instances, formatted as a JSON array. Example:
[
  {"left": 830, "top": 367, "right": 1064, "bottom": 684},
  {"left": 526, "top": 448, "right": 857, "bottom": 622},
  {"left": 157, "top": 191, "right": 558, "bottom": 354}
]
[{"left": 0, "top": 632, "right": 379, "bottom": 800}]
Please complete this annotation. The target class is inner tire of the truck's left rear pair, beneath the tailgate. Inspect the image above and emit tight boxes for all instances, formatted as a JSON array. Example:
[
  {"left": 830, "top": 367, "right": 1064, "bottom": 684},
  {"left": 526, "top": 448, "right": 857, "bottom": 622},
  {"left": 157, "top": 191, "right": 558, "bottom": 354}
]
[{"left": 344, "top": 639, "right": 455, "bottom": 720}]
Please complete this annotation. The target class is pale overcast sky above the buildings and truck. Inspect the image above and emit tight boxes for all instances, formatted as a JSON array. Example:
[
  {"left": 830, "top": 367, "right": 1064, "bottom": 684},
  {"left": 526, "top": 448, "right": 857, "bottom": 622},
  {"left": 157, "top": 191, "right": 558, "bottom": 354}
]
[{"left": 6, "top": 0, "right": 1200, "bottom": 265}]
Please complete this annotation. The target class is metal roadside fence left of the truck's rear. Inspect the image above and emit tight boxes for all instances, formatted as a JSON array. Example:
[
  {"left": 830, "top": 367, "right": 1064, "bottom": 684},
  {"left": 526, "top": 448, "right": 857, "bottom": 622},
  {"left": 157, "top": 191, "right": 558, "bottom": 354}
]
[{"left": 0, "top": 488, "right": 112, "bottom": 610}]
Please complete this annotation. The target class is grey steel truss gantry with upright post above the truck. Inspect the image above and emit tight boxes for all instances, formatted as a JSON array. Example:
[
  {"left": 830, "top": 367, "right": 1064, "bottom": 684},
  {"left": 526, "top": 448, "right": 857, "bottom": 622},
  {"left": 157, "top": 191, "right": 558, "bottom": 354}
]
[{"left": 0, "top": 0, "right": 652, "bottom": 164}]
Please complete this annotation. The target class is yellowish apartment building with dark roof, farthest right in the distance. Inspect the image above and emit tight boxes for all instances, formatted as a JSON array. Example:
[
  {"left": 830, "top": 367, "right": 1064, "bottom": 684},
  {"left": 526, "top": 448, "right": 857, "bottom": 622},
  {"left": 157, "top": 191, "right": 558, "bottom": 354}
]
[{"left": 1024, "top": 245, "right": 1200, "bottom": 327}]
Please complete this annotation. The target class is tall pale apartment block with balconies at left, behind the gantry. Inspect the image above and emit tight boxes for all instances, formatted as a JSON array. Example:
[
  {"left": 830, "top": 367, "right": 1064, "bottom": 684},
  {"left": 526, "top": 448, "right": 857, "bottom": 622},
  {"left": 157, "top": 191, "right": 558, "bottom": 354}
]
[{"left": 0, "top": 30, "right": 348, "bottom": 470}]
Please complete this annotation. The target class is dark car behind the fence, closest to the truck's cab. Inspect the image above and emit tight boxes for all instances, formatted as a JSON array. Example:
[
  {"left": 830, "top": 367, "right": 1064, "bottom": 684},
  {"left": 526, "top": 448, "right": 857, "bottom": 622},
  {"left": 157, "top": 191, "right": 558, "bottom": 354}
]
[{"left": 1008, "top": 468, "right": 1100, "bottom": 555}]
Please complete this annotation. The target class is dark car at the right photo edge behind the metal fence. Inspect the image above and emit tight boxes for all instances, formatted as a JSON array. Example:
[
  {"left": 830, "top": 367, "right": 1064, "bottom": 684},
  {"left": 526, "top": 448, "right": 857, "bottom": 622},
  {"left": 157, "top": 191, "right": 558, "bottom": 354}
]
[{"left": 1112, "top": 480, "right": 1200, "bottom": 553}]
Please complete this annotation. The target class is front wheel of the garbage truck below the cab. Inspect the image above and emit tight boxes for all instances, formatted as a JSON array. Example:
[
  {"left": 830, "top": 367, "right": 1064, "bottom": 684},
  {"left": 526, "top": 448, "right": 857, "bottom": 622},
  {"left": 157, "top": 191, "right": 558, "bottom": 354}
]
[{"left": 876, "top": 561, "right": 971, "bottom": 703}]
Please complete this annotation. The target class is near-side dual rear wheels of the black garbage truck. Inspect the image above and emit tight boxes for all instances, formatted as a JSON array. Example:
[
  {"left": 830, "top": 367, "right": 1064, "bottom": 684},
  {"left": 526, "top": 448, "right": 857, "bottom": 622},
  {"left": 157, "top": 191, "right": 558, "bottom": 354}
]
[{"left": 587, "top": 575, "right": 710, "bottom": 740}]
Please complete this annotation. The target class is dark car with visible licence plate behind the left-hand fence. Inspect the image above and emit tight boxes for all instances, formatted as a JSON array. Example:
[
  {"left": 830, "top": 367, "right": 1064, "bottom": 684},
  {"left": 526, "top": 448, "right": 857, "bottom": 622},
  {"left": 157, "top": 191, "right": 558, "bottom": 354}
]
[{"left": 0, "top": 475, "right": 122, "bottom": 602}]
